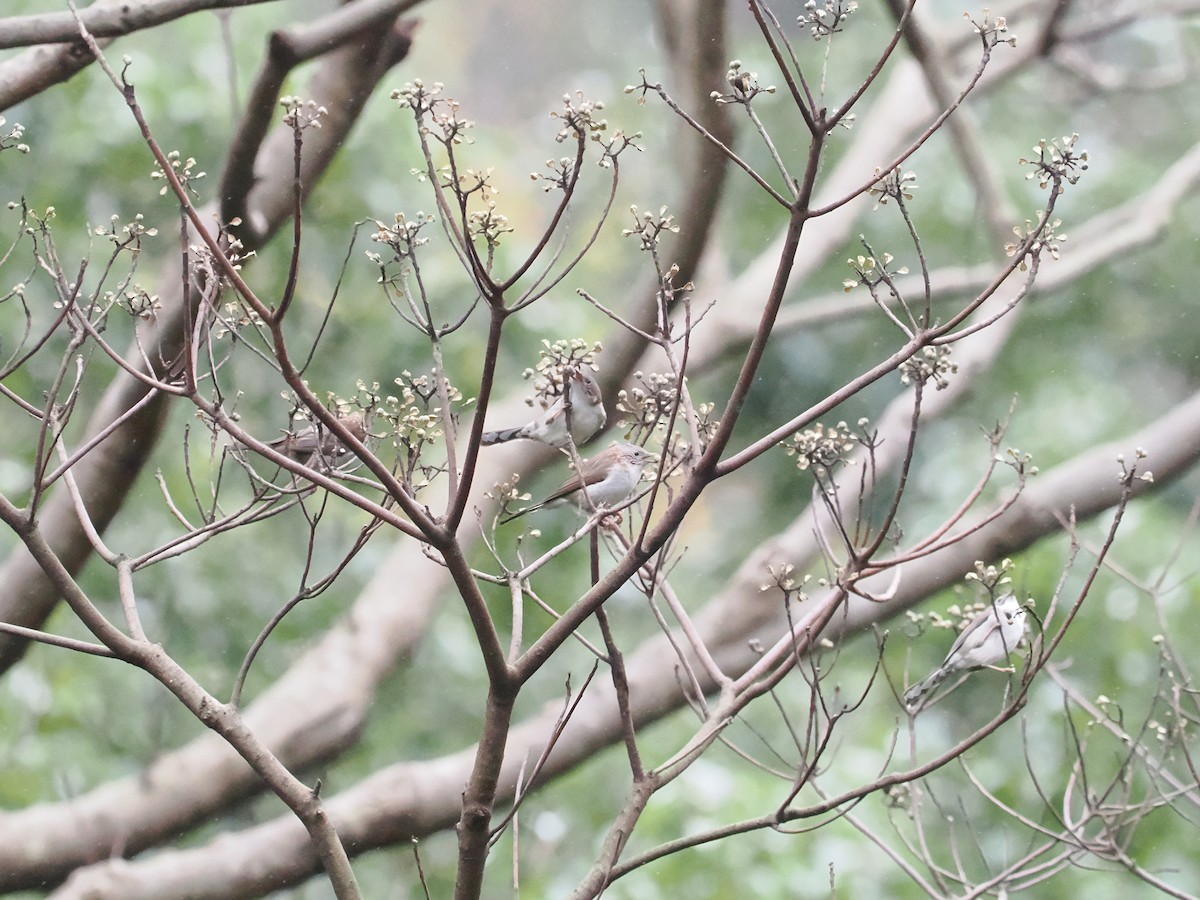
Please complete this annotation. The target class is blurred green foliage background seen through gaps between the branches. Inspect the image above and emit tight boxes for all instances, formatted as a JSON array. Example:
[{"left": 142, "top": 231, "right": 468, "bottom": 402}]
[{"left": 0, "top": 0, "right": 1200, "bottom": 900}]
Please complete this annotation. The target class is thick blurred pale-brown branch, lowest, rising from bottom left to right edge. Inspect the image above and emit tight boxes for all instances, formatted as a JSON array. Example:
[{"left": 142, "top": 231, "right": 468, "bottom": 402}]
[{"left": 30, "top": 384, "right": 1200, "bottom": 900}]
